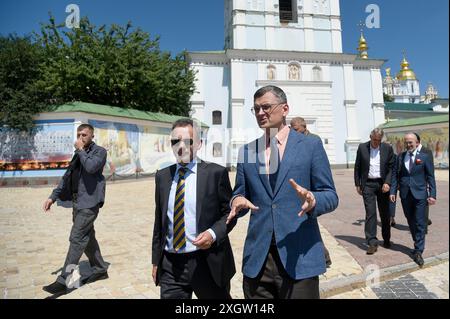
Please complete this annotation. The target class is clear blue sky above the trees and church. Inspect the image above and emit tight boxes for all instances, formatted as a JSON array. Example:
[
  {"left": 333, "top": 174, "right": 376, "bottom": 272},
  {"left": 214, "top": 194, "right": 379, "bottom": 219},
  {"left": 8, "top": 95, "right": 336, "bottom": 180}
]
[{"left": 0, "top": 0, "right": 449, "bottom": 97}]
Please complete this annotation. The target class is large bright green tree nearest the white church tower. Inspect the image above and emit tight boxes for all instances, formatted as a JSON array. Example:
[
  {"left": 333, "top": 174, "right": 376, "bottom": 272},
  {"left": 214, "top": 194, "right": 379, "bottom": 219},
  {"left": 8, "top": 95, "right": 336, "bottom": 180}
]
[{"left": 38, "top": 18, "right": 194, "bottom": 115}]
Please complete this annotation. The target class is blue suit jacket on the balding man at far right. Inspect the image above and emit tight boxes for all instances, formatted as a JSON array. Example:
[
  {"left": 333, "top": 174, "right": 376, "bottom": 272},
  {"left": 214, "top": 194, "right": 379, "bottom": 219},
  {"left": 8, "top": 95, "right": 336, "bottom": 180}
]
[{"left": 390, "top": 152, "right": 436, "bottom": 199}]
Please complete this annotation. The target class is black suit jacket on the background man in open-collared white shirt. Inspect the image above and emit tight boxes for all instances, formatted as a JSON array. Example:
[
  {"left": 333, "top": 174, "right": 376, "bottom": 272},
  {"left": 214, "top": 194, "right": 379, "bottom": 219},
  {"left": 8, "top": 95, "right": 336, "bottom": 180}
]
[{"left": 354, "top": 141, "right": 395, "bottom": 189}]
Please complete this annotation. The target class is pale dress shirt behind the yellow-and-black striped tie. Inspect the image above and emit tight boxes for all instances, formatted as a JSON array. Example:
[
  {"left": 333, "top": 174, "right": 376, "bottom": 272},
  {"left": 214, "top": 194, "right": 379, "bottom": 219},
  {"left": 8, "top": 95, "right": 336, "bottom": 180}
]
[{"left": 165, "top": 159, "right": 216, "bottom": 253}]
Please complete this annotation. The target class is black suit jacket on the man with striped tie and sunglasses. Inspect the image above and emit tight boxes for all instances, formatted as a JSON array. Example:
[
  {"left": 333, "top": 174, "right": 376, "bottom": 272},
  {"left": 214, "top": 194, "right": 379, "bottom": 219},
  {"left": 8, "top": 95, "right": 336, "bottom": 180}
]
[{"left": 152, "top": 161, "right": 236, "bottom": 287}]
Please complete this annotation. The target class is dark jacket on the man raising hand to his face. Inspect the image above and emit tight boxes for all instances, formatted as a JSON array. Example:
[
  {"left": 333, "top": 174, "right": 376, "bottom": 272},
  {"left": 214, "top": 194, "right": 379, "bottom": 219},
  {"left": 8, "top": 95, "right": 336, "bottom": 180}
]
[{"left": 50, "top": 143, "right": 107, "bottom": 209}]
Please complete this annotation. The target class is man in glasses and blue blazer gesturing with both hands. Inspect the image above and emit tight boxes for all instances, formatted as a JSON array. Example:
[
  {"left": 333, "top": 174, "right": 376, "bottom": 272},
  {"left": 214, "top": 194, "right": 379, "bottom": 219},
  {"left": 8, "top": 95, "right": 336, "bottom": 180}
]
[{"left": 228, "top": 86, "right": 338, "bottom": 299}]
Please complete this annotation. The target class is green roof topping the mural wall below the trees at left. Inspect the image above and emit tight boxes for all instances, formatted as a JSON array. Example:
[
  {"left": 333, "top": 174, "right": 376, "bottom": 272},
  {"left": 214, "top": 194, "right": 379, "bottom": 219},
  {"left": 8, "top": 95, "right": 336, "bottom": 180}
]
[{"left": 52, "top": 102, "right": 208, "bottom": 127}]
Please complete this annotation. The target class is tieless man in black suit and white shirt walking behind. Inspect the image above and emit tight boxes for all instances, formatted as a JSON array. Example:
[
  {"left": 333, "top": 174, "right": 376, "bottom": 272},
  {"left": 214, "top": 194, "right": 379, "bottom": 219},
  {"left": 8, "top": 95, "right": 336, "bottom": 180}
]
[{"left": 354, "top": 128, "right": 394, "bottom": 255}]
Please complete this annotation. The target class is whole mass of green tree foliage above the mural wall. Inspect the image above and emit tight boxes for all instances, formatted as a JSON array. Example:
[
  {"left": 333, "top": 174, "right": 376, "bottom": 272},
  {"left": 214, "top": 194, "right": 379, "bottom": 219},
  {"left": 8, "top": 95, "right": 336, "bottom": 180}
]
[{"left": 0, "top": 17, "right": 195, "bottom": 129}]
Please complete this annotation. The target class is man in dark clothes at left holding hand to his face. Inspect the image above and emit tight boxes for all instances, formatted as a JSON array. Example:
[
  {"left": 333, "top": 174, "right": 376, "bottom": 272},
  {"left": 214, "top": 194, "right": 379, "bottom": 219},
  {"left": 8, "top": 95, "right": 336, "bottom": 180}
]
[{"left": 43, "top": 124, "right": 108, "bottom": 294}]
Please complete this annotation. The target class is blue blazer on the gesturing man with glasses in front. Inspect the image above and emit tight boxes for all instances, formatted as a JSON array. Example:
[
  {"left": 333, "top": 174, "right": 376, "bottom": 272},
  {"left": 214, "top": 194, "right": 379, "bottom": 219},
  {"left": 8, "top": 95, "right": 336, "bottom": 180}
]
[{"left": 233, "top": 130, "right": 338, "bottom": 280}]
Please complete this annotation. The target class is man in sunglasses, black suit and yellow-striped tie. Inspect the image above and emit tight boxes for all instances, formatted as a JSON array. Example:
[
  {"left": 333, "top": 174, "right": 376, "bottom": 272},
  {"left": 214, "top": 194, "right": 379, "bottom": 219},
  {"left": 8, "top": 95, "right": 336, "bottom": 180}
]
[{"left": 152, "top": 119, "right": 236, "bottom": 299}]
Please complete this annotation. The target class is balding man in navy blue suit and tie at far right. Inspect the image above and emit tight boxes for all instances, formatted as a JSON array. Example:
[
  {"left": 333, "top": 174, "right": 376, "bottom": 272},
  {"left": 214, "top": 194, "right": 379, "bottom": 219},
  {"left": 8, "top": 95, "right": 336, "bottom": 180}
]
[{"left": 390, "top": 133, "right": 436, "bottom": 267}]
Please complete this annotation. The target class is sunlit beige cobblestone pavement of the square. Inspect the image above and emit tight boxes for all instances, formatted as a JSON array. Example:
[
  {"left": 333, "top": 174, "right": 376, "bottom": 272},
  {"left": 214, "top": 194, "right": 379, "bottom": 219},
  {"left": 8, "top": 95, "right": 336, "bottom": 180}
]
[{"left": 0, "top": 171, "right": 448, "bottom": 298}]
